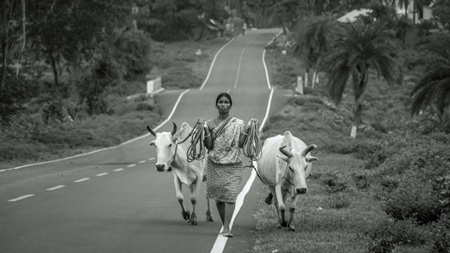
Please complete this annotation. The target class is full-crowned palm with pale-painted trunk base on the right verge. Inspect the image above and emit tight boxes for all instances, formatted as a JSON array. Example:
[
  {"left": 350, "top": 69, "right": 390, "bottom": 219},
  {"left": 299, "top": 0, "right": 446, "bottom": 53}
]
[{"left": 324, "top": 21, "right": 399, "bottom": 138}]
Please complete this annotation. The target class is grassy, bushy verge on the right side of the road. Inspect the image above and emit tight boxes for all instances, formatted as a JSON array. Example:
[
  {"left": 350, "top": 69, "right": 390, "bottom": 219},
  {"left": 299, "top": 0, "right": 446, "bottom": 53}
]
[{"left": 252, "top": 44, "right": 450, "bottom": 253}]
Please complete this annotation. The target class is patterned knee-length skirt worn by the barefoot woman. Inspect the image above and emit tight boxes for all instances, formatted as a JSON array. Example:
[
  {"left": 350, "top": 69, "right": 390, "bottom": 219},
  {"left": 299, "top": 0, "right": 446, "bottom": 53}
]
[{"left": 206, "top": 159, "right": 244, "bottom": 203}]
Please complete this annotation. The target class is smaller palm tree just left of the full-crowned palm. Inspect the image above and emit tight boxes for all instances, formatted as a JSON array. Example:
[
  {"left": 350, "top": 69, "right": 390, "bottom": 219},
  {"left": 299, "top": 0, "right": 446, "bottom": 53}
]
[{"left": 294, "top": 15, "right": 335, "bottom": 88}]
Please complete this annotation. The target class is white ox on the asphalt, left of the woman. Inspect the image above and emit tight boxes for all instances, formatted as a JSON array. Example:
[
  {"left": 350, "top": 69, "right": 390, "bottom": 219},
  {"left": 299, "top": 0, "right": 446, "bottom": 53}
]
[{"left": 147, "top": 122, "right": 213, "bottom": 225}]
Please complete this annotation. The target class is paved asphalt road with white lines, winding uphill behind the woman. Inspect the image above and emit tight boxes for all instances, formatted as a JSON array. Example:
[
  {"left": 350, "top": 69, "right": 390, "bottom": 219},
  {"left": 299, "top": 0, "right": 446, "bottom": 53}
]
[{"left": 0, "top": 30, "right": 288, "bottom": 253}]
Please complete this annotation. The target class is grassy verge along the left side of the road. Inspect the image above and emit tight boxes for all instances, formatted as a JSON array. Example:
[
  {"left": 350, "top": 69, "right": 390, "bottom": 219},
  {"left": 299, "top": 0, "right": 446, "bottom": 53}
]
[{"left": 0, "top": 39, "right": 227, "bottom": 169}]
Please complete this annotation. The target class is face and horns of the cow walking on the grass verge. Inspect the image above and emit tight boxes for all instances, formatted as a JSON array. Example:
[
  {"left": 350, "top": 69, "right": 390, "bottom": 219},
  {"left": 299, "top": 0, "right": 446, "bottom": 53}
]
[{"left": 280, "top": 144, "right": 317, "bottom": 194}]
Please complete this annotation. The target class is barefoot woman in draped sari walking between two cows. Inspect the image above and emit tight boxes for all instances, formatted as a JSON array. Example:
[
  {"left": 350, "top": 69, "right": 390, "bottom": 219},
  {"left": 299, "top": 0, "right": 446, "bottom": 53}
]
[{"left": 204, "top": 93, "right": 249, "bottom": 237}]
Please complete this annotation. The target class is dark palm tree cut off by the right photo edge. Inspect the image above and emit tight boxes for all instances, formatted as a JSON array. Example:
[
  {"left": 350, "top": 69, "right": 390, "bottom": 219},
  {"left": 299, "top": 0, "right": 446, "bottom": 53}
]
[{"left": 411, "top": 33, "right": 450, "bottom": 120}]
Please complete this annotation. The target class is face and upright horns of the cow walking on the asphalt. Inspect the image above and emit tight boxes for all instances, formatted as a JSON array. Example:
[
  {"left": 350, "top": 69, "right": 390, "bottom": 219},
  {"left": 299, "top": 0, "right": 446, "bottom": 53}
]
[{"left": 147, "top": 123, "right": 177, "bottom": 172}]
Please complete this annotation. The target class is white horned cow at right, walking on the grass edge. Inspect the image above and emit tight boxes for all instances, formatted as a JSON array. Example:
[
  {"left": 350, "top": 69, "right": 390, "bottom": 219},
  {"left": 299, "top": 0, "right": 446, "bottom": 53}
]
[{"left": 258, "top": 131, "right": 317, "bottom": 231}]
